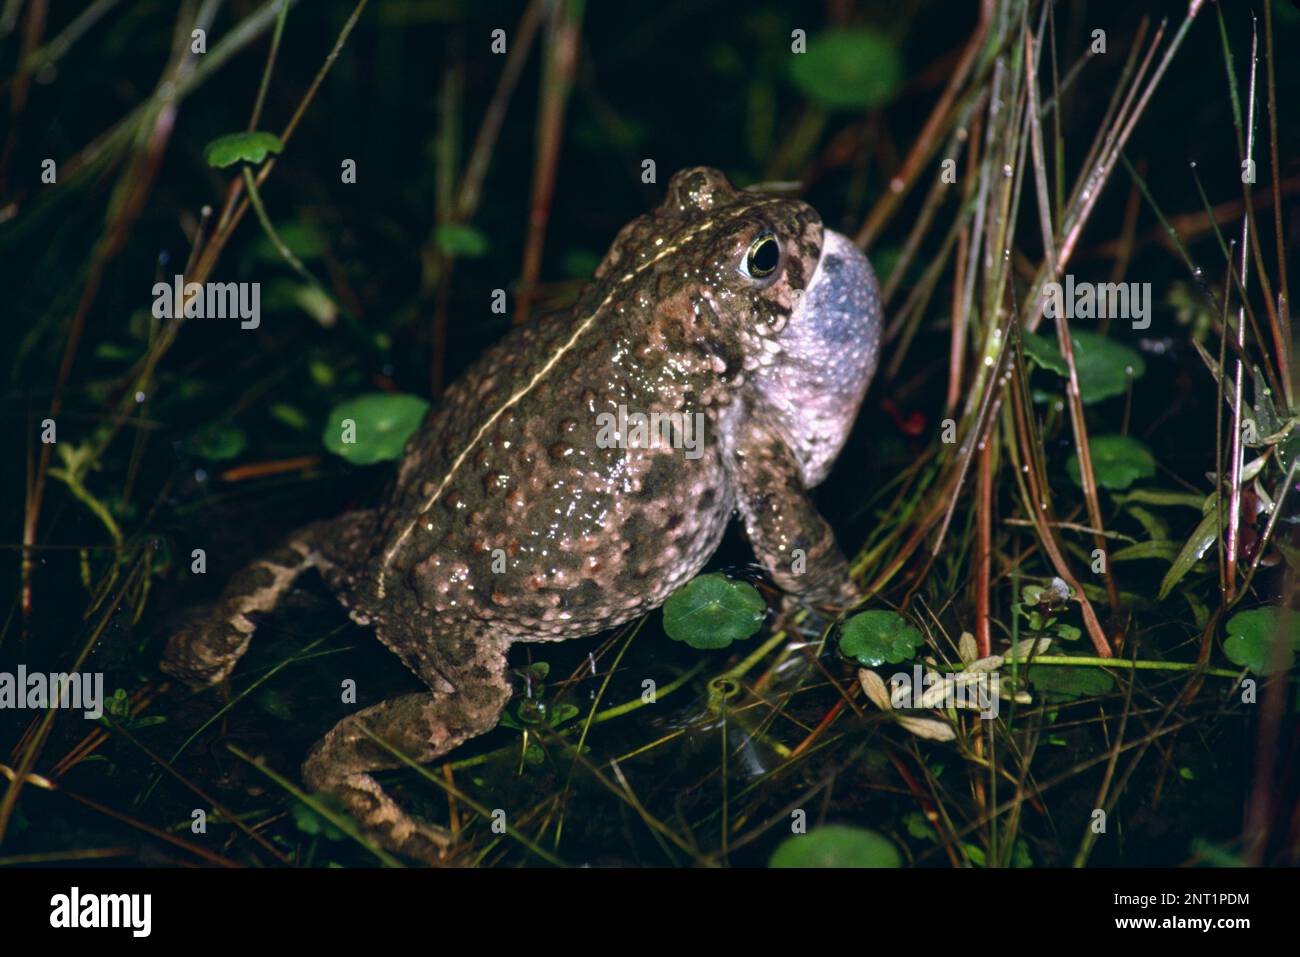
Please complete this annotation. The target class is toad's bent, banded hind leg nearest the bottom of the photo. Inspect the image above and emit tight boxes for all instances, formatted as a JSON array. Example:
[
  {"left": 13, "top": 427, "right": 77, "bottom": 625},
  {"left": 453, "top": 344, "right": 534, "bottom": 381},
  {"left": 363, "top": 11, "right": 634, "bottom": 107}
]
[{"left": 303, "top": 629, "right": 511, "bottom": 863}]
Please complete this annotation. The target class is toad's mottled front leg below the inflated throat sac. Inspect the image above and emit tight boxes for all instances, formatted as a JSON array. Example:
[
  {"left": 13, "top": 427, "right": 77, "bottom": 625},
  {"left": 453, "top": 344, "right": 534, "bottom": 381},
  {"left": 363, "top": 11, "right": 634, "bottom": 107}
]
[{"left": 727, "top": 415, "right": 862, "bottom": 610}]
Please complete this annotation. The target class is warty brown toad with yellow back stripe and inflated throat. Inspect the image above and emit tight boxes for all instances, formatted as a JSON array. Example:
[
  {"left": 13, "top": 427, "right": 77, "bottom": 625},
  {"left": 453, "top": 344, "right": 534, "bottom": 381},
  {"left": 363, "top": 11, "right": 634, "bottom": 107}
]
[{"left": 163, "top": 168, "right": 880, "bottom": 859}]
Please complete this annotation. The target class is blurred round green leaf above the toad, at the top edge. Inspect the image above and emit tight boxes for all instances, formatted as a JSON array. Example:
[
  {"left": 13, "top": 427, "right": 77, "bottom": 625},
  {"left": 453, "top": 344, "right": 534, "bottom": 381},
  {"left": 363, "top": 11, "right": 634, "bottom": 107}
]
[{"left": 790, "top": 30, "right": 902, "bottom": 109}]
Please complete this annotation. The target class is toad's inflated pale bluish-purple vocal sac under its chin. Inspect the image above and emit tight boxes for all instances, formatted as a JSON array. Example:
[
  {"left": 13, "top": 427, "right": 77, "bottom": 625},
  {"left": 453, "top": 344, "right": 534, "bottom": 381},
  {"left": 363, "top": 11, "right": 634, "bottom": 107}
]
[{"left": 764, "top": 229, "right": 881, "bottom": 488}]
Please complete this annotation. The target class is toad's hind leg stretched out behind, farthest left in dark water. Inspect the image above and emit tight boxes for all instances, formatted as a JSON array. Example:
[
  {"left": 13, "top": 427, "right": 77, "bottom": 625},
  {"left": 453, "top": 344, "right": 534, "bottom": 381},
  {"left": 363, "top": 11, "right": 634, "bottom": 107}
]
[{"left": 160, "top": 511, "right": 374, "bottom": 688}]
